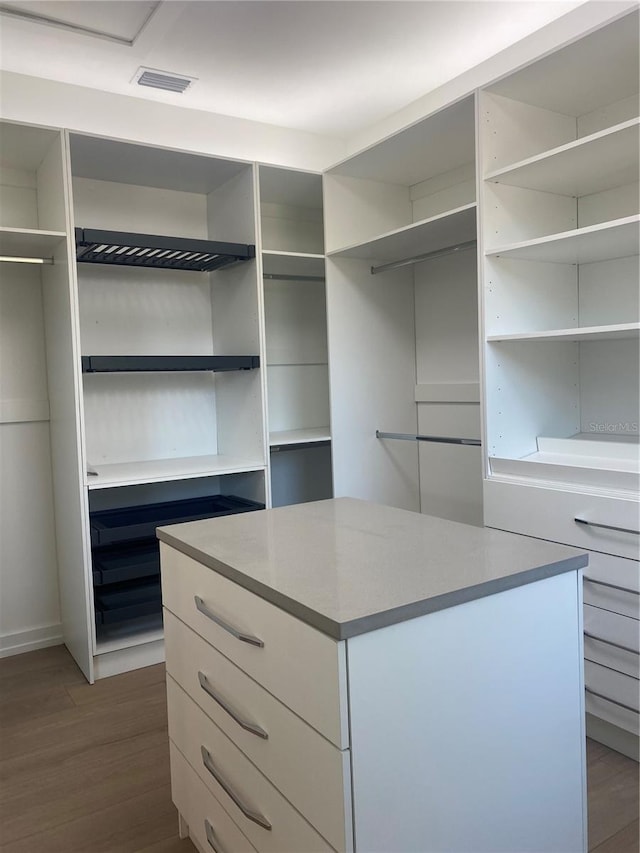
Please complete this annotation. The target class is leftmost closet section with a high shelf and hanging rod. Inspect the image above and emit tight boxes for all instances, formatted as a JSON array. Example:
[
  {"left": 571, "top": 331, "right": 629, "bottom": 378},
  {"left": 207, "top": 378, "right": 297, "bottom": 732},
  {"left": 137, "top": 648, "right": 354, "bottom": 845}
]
[{"left": 0, "top": 122, "right": 69, "bottom": 653}]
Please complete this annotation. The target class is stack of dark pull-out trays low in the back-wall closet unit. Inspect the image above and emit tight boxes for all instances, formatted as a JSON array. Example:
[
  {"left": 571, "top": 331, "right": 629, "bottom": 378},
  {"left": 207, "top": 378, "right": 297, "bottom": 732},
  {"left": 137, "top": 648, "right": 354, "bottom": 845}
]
[{"left": 90, "top": 495, "right": 263, "bottom": 634}]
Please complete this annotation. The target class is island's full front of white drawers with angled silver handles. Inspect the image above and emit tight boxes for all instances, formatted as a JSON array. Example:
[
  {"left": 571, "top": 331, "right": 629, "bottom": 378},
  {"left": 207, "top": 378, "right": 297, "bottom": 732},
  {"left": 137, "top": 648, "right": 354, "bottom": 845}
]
[{"left": 160, "top": 545, "right": 353, "bottom": 853}]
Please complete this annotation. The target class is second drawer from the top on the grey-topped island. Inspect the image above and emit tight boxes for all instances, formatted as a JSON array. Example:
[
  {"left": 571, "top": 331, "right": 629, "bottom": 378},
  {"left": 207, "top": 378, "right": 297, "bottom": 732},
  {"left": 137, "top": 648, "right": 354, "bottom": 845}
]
[{"left": 164, "top": 610, "right": 353, "bottom": 851}]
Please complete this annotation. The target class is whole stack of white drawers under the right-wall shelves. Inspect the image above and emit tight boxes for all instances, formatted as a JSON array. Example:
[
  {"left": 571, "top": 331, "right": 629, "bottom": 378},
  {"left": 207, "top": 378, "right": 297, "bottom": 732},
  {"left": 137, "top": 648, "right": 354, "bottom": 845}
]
[{"left": 485, "top": 481, "right": 640, "bottom": 760}]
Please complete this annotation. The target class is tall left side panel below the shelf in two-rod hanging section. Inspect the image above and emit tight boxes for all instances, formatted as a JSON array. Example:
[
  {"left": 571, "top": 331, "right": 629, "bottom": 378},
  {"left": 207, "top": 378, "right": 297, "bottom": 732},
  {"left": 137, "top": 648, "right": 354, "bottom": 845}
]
[{"left": 327, "top": 253, "right": 419, "bottom": 510}]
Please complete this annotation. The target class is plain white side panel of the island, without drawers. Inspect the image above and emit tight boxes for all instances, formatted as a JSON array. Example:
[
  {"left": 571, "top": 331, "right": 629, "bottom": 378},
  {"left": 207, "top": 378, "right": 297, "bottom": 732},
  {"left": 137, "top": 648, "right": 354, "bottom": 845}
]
[{"left": 347, "top": 572, "right": 587, "bottom": 853}]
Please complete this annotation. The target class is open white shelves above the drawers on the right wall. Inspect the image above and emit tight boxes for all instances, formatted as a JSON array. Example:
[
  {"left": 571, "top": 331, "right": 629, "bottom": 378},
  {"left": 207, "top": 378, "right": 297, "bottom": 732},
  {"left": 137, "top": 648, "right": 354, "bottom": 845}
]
[{"left": 480, "top": 12, "right": 640, "bottom": 492}]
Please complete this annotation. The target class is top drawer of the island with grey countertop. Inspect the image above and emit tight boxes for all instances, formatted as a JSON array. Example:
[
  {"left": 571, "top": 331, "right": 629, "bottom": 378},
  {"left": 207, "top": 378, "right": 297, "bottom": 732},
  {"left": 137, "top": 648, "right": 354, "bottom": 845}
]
[{"left": 160, "top": 543, "right": 349, "bottom": 749}]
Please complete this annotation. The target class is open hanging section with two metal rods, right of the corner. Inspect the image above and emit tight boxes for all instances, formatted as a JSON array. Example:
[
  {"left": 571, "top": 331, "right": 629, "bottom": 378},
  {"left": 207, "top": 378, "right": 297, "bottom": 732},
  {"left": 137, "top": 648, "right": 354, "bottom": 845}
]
[{"left": 325, "top": 97, "right": 482, "bottom": 524}]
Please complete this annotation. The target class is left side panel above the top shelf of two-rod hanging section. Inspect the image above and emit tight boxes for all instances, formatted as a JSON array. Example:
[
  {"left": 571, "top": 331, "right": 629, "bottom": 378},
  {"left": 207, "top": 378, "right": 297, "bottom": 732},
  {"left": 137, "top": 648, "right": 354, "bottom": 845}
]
[{"left": 324, "top": 173, "right": 413, "bottom": 252}]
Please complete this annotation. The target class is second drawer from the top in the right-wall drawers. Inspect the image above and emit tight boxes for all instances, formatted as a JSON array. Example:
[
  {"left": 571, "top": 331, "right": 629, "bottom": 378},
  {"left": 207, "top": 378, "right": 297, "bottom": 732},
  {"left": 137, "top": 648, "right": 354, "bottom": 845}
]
[{"left": 584, "top": 553, "right": 640, "bottom": 619}]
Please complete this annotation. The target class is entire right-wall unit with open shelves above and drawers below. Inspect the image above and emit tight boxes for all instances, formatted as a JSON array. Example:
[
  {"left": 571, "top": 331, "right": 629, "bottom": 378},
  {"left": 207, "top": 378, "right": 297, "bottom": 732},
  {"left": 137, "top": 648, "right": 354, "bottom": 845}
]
[{"left": 479, "top": 10, "right": 640, "bottom": 757}]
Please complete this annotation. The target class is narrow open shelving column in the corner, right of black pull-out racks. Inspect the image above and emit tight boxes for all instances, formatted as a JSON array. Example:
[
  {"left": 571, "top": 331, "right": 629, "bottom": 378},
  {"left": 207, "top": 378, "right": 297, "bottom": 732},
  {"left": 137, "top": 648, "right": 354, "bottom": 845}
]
[{"left": 259, "top": 166, "right": 332, "bottom": 506}]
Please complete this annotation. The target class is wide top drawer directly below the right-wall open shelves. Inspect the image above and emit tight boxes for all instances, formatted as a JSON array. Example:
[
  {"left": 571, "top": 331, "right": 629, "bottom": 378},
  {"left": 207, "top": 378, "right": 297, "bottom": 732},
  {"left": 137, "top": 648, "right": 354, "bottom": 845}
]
[{"left": 484, "top": 480, "right": 640, "bottom": 560}]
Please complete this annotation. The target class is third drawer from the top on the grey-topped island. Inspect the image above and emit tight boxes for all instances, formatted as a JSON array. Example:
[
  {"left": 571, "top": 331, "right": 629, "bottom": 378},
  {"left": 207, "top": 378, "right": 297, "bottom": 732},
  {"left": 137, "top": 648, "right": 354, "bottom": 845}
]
[{"left": 167, "top": 676, "right": 332, "bottom": 853}]
